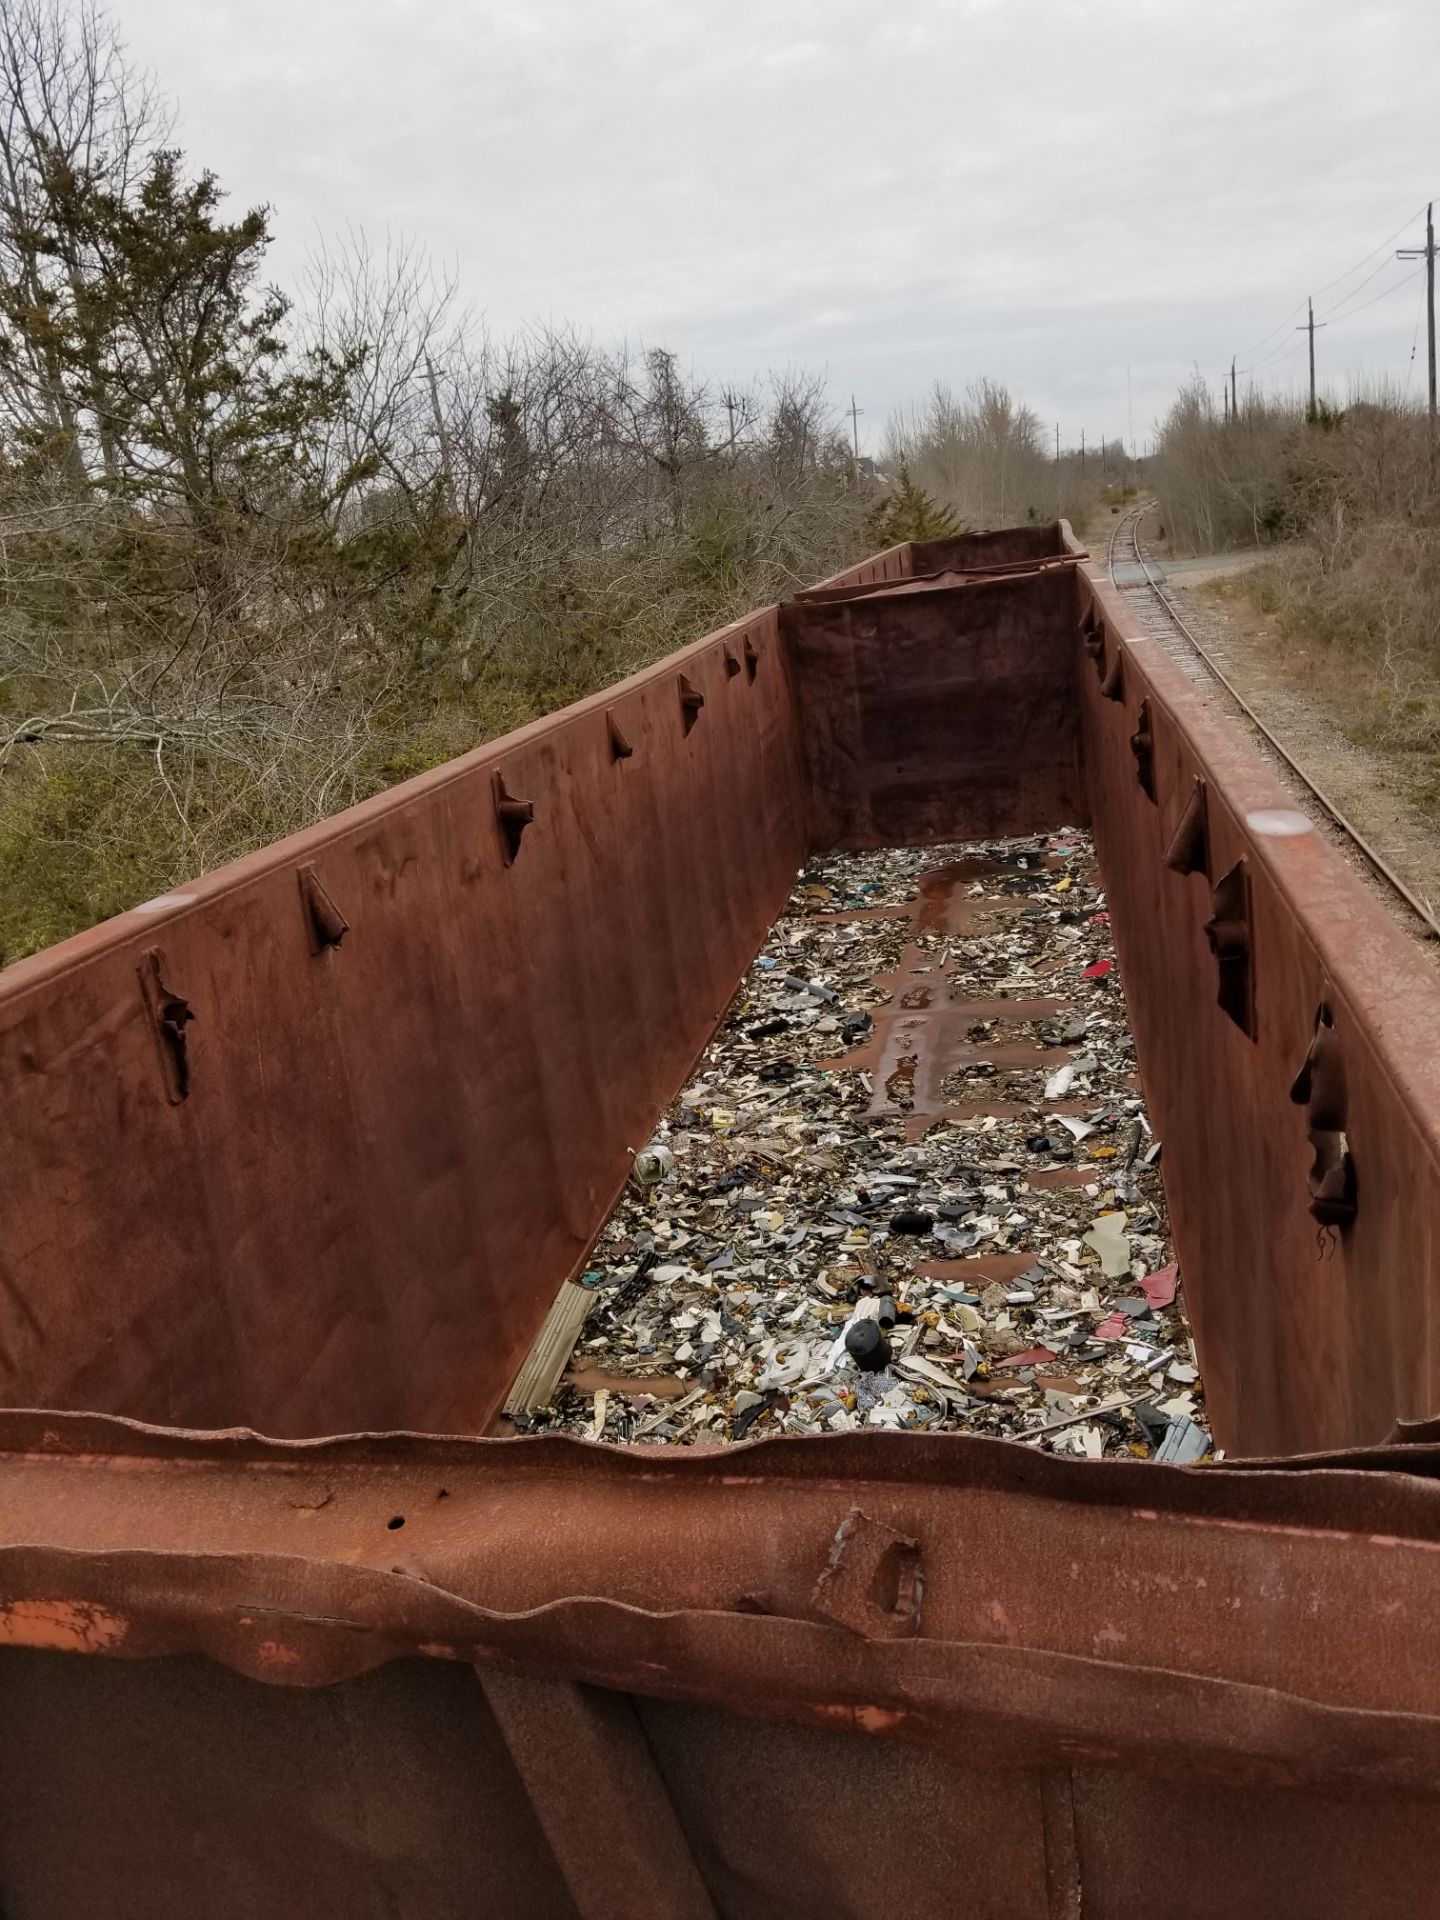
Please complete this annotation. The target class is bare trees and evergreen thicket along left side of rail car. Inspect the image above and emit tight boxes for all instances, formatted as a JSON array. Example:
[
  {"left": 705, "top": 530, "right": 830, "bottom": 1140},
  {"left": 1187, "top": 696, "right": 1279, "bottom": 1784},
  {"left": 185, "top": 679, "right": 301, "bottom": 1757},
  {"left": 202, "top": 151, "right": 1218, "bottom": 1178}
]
[{"left": 0, "top": 0, "right": 874, "bottom": 956}]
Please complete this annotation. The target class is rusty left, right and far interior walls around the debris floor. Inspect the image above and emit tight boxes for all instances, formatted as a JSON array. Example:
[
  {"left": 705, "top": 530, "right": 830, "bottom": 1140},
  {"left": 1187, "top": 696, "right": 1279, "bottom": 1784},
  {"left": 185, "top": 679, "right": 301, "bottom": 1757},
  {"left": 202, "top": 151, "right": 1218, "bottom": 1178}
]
[{"left": 0, "top": 526, "right": 1440, "bottom": 1453}]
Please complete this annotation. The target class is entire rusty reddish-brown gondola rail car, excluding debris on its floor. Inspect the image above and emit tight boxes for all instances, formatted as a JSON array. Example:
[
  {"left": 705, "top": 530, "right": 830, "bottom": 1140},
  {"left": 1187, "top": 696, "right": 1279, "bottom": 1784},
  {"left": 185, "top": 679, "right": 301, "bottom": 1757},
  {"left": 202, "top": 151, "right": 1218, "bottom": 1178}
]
[{"left": 0, "top": 526, "right": 1440, "bottom": 1920}]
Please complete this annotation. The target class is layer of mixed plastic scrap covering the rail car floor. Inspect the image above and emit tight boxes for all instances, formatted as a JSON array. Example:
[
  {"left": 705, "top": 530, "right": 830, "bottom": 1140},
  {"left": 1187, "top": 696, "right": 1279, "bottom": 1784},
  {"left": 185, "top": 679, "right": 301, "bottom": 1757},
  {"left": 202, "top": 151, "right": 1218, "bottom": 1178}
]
[{"left": 518, "top": 831, "right": 1212, "bottom": 1465}]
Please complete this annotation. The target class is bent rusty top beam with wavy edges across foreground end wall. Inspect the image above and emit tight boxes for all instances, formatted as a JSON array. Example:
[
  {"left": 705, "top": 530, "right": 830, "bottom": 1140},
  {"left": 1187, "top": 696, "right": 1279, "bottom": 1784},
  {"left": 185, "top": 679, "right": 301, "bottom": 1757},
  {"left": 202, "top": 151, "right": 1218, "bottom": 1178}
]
[{"left": 14, "top": 1413, "right": 1440, "bottom": 1758}]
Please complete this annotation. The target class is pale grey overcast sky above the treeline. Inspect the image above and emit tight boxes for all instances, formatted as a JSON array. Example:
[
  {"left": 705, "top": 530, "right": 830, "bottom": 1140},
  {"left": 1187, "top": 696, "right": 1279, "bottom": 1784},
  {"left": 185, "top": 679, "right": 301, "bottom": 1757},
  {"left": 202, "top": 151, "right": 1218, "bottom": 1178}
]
[{"left": 115, "top": 0, "right": 1440, "bottom": 444}]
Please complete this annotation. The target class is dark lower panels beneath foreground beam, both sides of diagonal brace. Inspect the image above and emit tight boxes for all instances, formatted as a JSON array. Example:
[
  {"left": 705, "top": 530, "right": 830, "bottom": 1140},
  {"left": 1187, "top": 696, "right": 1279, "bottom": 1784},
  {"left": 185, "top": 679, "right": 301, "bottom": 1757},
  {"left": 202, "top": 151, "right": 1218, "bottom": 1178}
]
[{"left": 0, "top": 1658, "right": 1440, "bottom": 1920}]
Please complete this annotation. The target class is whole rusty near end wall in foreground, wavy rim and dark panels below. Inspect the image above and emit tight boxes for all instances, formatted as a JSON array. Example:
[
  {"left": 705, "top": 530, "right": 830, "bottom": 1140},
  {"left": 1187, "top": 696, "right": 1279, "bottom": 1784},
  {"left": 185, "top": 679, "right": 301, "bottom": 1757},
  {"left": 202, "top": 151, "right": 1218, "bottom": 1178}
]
[{"left": 0, "top": 1413, "right": 1440, "bottom": 1920}]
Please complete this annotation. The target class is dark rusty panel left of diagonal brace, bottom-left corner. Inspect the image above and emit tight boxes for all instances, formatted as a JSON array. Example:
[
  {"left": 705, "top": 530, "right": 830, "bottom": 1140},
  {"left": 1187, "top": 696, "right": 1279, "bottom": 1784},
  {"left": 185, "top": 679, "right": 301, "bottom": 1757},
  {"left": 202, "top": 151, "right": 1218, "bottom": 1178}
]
[{"left": 0, "top": 1651, "right": 586, "bottom": 1920}]
